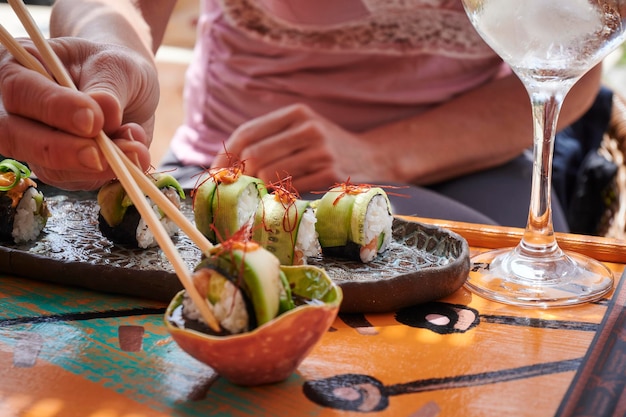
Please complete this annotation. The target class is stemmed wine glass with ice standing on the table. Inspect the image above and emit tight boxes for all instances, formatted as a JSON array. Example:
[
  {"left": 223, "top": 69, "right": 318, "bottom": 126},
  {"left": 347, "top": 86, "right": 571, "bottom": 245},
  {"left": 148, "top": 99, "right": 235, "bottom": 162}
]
[{"left": 462, "top": 0, "right": 626, "bottom": 307}]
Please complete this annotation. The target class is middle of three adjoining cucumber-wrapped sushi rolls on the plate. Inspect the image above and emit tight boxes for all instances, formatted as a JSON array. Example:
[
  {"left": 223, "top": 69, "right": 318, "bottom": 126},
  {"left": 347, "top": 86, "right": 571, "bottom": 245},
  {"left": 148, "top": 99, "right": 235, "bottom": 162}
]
[{"left": 252, "top": 192, "right": 322, "bottom": 265}]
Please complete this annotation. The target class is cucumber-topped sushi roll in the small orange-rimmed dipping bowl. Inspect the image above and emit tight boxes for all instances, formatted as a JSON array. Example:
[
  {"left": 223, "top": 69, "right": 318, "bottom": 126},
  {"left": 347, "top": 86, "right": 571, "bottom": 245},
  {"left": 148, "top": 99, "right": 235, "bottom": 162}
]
[{"left": 183, "top": 238, "right": 295, "bottom": 335}]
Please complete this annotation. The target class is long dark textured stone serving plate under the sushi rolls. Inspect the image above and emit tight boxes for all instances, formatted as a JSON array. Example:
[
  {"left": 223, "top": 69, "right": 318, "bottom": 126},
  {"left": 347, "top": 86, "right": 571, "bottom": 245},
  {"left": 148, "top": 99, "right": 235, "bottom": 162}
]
[{"left": 0, "top": 188, "right": 470, "bottom": 313}]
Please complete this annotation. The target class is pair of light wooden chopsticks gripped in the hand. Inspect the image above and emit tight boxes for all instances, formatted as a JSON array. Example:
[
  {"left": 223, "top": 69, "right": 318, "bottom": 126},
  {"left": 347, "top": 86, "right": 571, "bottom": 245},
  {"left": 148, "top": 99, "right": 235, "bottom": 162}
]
[{"left": 0, "top": 0, "right": 220, "bottom": 331}]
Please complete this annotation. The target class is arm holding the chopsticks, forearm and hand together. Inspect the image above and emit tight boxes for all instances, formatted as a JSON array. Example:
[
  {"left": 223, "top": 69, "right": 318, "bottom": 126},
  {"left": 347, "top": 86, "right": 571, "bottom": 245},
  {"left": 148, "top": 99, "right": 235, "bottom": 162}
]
[{"left": 0, "top": 0, "right": 175, "bottom": 189}]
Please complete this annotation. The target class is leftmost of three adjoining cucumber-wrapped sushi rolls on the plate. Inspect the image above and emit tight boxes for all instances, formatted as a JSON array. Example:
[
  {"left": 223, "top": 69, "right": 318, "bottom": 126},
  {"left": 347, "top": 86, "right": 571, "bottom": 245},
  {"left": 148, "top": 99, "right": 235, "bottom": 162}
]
[{"left": 193, "top": 168, "right": 267, "bottom": 243}]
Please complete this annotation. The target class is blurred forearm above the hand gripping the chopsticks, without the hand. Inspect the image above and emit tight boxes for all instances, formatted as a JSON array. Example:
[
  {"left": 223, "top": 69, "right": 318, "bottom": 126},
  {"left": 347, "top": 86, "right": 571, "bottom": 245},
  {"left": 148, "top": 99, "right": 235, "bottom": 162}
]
[{"left": 50, "top": 0, "right": 176, "bottom": 56}]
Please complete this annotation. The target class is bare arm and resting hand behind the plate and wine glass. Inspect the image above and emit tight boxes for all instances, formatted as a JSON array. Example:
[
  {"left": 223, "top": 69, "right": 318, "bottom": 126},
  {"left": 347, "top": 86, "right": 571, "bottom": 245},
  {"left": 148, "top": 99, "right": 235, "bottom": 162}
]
[{"left": 213, "top": 63, "right": 601, "bottom": 192}]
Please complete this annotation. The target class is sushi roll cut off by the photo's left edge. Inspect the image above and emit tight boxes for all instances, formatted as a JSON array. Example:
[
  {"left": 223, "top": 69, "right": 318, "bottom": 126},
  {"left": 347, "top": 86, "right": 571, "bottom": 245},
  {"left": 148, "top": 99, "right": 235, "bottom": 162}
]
[{"left": 0, "top": 159, "right": 50, "bottom": 243}]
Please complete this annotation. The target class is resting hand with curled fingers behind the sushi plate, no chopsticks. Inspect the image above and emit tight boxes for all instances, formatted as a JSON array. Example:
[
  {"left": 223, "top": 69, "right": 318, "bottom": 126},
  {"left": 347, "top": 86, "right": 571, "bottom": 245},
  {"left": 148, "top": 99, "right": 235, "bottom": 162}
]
[{"left": 213, "top": 104, "right": 393, "bottom": 192}]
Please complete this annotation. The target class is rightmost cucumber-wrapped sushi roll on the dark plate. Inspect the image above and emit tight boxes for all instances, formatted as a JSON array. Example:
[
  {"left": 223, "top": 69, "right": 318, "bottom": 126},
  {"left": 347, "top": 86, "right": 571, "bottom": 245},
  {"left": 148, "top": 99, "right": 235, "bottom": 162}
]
[{"left": 315, "top": 184, "right": 393, "bottom": 263}]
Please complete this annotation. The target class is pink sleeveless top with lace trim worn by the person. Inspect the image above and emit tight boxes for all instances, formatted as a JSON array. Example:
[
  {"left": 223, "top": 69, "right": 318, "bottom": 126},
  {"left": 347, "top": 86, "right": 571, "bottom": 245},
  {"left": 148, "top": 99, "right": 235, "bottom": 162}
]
[{"left": 171, "top": 0, "right": 503, "bottom": 167}]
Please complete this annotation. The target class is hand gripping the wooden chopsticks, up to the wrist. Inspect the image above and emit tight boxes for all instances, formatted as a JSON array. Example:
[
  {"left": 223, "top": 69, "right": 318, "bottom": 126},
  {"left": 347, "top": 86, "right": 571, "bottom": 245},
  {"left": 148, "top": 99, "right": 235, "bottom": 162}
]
[{"left": 0, "top": 38, "right": 158, "bottom": 190}]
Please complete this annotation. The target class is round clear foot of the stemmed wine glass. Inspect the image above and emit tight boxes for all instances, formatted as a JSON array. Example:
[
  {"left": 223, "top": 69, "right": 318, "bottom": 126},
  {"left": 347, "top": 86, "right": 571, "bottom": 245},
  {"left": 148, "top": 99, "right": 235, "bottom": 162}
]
[{"left": 466, "top": 248, "right": 613, "bottom": 307}]
